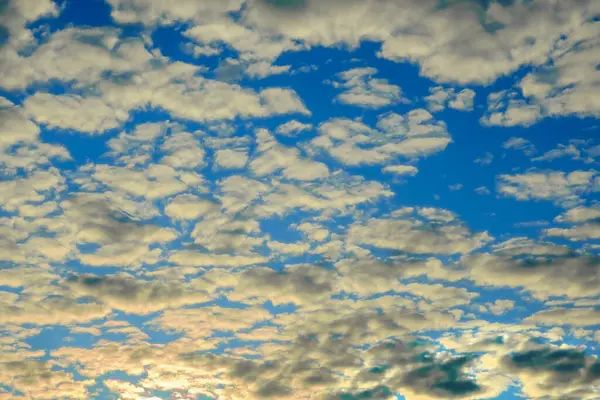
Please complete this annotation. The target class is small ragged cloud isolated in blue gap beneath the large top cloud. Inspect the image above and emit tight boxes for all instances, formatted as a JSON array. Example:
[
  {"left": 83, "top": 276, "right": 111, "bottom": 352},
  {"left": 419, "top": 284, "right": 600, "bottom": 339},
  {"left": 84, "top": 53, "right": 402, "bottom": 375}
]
[{"left": 332, "top": 68, "right": 406, "bottom": 108}]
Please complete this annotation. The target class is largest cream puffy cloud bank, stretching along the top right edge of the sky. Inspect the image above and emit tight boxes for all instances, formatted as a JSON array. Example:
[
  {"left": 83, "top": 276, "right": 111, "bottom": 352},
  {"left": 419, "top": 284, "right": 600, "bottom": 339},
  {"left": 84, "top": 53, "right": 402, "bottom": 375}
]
[{"left": 244, "top": 1, "right": 595, "bottom": 89}]
